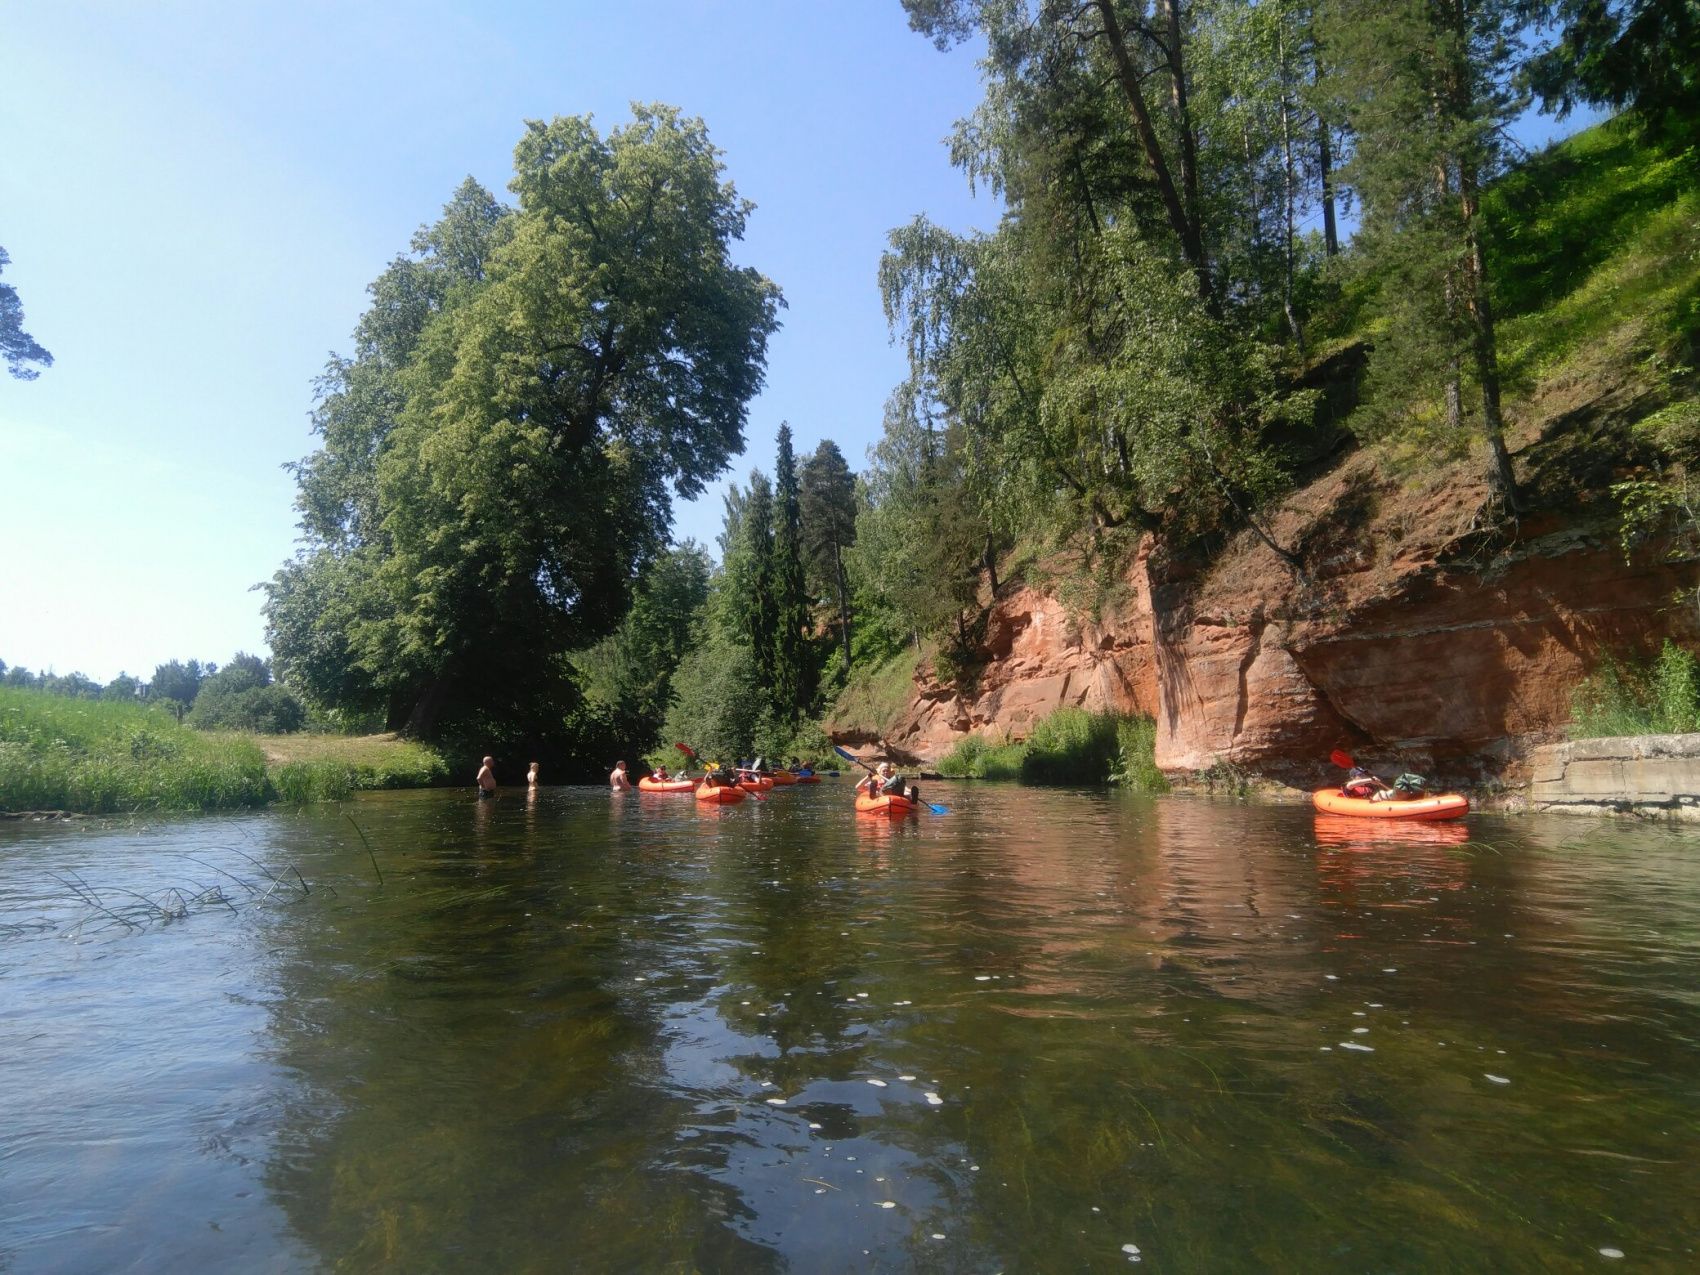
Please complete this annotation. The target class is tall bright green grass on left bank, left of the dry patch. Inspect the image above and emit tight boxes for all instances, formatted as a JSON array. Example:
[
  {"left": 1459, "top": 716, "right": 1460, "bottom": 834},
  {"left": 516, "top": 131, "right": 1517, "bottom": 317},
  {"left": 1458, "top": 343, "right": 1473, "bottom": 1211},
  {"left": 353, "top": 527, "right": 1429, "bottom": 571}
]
[{"left": 0, "top": 687, "right": 269, "bottom": 813}]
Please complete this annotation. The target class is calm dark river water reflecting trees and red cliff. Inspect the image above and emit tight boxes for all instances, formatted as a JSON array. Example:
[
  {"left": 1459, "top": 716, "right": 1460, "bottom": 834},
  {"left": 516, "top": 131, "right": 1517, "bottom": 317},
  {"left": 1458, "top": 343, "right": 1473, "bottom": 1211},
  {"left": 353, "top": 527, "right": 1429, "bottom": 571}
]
[{"left": 0, "top": 780, "right": 1700, "bottom": 1275}]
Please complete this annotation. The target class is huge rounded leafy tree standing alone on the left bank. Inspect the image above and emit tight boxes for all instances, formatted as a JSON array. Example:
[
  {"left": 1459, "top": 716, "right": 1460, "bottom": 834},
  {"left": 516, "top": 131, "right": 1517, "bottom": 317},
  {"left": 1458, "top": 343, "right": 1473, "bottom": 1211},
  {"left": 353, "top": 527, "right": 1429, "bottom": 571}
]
[{"left": 267, "top": 107, "right": 780, "bottom": 748}]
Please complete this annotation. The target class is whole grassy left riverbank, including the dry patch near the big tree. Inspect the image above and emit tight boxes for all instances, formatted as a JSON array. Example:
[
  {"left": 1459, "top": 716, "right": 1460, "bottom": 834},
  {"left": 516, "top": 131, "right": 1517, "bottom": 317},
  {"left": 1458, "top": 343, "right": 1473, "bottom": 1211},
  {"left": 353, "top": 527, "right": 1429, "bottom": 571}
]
[{"left": 0, "top": 687, "right": 444, "bottom": 814}]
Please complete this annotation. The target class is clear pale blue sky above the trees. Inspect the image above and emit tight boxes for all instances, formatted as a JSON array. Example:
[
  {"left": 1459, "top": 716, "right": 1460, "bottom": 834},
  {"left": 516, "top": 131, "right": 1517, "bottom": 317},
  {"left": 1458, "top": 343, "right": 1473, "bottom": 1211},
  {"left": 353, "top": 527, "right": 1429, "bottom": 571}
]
[{"left": 0, "top": 0, "right": 1574, "bottom": 682}]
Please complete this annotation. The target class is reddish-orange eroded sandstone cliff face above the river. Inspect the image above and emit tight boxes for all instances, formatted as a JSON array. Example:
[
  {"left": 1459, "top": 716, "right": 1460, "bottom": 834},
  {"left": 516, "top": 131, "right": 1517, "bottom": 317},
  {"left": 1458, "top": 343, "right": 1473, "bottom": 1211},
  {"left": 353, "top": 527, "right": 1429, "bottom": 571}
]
[{"left": 839, "top": 462, "right": 1695, "bottom": 782}]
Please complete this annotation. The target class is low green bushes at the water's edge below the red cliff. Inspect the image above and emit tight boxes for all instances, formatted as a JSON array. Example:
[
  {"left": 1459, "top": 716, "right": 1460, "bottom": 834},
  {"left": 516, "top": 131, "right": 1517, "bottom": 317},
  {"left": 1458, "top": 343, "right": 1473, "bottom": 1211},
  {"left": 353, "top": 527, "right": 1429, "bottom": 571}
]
[{"left": 938, "top": 707, "right": 1168, "bottom": 792}]
